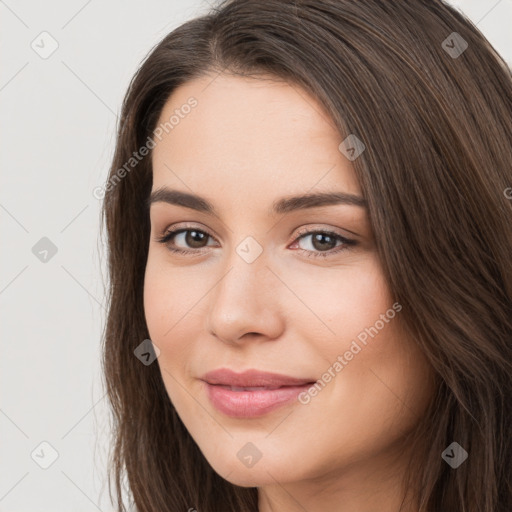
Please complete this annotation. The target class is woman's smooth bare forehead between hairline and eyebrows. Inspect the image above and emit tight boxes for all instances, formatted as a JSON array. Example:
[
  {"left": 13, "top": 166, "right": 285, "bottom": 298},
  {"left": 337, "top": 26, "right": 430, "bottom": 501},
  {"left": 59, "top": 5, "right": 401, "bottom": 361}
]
[{"left": 152, "top": 74, "right": 361, "bottom": 199}]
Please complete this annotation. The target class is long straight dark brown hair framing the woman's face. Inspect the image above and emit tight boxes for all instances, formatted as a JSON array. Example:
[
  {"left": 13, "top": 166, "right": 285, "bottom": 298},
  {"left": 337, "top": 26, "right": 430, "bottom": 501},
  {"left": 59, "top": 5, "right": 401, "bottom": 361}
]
[{"left": 102, "top": 0, "right": 512, "bottom": 512}]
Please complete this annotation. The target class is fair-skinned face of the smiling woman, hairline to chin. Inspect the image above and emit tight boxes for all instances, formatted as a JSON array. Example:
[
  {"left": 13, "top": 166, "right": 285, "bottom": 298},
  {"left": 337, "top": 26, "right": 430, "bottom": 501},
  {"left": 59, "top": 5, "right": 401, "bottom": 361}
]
[{"left": 144, "top": 74, "right": 431, "bottom": 492}]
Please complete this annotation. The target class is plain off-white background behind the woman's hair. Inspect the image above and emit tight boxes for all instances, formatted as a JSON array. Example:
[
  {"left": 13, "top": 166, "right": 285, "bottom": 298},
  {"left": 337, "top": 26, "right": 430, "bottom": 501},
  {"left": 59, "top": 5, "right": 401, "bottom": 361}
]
[{"left": 0, "top": 0, "right": 512, "bottom": 512}]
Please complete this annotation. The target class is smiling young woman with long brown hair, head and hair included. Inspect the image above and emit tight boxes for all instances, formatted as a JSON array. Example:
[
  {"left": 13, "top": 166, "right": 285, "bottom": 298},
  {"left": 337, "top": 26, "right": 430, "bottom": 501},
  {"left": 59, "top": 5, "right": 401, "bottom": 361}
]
[{"left": 103, "top": 0, "right": 512, "bottom": 512}]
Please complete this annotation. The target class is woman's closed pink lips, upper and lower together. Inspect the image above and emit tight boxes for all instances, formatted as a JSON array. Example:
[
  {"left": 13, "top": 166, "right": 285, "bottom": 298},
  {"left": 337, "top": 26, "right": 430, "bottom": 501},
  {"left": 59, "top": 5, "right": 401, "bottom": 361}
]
[{"left": 201, "top": 368, "right": 315, "bottom": 418}]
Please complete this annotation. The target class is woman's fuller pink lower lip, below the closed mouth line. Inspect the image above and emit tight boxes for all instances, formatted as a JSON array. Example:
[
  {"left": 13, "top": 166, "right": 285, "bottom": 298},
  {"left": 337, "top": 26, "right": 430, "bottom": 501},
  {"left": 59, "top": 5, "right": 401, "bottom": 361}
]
[{"left": 205, "top": 382, "right": 313, "bottom": 418}]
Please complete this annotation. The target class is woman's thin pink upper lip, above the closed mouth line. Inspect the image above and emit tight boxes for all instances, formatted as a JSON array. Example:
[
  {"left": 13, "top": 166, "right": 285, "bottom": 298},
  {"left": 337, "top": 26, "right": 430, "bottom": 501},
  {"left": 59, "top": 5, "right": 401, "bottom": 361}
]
[{"left": 201, "top": 368, "right": 315, "bottom": 387}]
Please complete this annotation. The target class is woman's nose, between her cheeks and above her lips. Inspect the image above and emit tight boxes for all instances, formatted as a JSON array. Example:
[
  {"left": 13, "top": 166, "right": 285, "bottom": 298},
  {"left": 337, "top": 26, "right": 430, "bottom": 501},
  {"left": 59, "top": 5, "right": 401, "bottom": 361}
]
[{"left": 207, "top": 247, "right": 289, "bottom": 345}]
